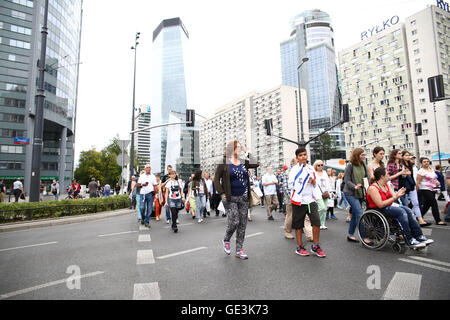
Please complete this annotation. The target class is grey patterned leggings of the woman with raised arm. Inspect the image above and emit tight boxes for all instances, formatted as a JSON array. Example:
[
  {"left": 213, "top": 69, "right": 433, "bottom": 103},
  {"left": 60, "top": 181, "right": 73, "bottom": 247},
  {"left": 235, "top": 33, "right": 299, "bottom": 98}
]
[{"left": 222, "top": 194, "right": 248, "bottom": 251}]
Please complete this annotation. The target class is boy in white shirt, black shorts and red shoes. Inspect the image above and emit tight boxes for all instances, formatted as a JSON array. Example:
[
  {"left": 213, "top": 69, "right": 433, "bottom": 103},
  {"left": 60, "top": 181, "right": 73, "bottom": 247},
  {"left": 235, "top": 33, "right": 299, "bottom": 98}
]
[{"left": 288, "top": 147, "right": 326, "bottom": 258}]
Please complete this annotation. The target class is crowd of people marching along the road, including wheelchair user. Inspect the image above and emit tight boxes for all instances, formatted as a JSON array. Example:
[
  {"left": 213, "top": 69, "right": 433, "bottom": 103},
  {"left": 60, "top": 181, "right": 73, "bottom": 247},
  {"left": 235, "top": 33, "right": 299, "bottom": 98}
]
[{"left": 125, "top": 141, "right": 450, "bottom": 259}]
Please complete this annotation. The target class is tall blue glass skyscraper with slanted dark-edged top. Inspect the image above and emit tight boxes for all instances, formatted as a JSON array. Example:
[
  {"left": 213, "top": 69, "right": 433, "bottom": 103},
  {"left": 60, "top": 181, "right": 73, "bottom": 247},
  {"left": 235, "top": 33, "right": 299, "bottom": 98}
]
[{"left": 151, "top": 18, "right": 200, "bottom": 180}]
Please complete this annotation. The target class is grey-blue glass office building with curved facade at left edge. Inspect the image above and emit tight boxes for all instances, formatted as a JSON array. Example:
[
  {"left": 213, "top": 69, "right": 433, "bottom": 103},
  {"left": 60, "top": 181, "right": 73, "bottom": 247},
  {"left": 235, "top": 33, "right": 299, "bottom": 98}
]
[{"left": 0, "top": 0, "right": 82, "bottom": 193}]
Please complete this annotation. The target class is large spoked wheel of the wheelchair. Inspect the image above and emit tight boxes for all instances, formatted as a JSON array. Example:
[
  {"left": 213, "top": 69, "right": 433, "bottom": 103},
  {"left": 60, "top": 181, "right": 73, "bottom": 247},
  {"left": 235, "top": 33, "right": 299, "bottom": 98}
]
[{"left": 358, "top": 209, "right": 390, "bottom": 250}]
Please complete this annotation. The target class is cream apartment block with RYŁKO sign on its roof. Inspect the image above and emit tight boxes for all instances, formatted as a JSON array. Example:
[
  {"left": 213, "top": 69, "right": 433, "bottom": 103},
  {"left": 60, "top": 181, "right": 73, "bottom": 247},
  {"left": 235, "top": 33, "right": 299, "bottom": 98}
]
[{"left": 339, "top": 6, "right": 450, "bottom": 156}]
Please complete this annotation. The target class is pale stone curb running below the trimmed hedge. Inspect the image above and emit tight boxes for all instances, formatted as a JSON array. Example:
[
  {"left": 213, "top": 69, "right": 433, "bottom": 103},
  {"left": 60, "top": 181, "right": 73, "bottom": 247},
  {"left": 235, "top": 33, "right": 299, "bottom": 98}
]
[{"left": 0, "top": 209, "right": 136, "bottom": 233}]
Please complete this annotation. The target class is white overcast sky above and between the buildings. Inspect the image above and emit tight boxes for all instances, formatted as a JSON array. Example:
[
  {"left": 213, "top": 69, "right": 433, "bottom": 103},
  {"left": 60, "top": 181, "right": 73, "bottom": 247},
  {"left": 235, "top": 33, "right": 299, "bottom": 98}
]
[{"left": 75, "top": 0, "right": 430, "bottom": 162}]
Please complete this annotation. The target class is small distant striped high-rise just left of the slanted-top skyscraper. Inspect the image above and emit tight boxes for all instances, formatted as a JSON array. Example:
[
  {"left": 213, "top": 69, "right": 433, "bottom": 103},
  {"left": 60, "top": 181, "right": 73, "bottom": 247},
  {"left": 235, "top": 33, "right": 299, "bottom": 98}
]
[{"left": 134, "top": 105, "right": 152, "bottom": 169}]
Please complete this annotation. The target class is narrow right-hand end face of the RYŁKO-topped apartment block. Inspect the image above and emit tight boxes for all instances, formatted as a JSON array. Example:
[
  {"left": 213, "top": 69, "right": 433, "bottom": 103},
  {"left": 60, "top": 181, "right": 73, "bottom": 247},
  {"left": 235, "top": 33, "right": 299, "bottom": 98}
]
[{"left": 405, "top": 6, "right": 450, "bottom": 156}]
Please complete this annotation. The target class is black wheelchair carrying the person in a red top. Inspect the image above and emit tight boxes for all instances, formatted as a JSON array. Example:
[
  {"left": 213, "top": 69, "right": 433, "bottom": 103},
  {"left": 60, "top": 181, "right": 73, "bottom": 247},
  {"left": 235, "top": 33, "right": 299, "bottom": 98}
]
[{"left": 358, "top": 208, "right": 423, "bottom": 254}]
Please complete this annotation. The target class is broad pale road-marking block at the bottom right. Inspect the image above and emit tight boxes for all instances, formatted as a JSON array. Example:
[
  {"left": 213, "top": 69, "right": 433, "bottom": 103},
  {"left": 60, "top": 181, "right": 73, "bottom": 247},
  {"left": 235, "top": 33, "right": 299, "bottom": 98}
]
[{"left": 381, "top": 272, "right": 422, "bottom": 300}]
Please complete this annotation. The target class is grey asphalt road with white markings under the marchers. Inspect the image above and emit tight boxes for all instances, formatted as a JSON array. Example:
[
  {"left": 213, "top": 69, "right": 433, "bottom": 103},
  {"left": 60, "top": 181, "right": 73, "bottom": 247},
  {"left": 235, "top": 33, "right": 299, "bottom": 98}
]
[{"left": 0, "top": 202, "right": 450, "bottom": 300}]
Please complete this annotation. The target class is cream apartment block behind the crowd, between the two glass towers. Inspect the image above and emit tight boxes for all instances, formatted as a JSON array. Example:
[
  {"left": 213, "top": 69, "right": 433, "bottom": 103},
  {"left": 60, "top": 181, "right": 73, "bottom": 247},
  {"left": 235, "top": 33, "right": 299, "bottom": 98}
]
[{"left": 200, "top": 86, "right": 309, "bottom": 175}]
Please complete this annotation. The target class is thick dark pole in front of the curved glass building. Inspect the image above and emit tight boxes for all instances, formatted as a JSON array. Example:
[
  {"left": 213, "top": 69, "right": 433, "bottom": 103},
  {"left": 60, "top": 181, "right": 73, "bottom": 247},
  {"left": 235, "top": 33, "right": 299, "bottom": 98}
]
[{"left": 30, "top": 0, "right": 48, "bottom": 202}]
